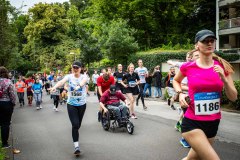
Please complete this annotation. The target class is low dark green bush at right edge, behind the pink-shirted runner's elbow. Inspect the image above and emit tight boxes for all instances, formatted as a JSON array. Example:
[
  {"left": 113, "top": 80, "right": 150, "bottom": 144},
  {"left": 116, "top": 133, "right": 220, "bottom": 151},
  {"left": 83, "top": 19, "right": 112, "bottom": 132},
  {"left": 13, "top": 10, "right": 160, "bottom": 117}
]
[{"left": 222, "top": 80, "right": 240, "bottom": 110}]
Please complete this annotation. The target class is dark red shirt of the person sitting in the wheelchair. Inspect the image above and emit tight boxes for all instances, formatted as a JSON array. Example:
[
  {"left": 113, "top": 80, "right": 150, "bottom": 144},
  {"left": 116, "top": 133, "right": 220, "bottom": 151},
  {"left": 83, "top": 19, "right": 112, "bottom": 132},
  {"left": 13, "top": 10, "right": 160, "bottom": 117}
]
[{"left": 100, "top": 90, "right": 126, "bottom": 105}]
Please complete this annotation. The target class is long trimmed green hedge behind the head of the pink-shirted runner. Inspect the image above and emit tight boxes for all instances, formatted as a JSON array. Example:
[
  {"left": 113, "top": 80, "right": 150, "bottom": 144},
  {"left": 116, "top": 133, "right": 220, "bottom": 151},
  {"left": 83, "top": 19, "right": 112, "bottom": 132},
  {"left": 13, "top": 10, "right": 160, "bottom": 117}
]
[{"left": 128, "top": 51, "right": 240, "bottom": 69}]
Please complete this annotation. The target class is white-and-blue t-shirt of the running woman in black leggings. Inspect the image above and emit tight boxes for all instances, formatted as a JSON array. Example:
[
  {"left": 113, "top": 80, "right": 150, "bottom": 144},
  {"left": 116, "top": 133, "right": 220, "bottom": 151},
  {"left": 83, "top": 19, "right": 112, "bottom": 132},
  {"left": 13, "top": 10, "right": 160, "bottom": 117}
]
[{"left": 64, "top": 74, "right": 87, "bottom": 106}]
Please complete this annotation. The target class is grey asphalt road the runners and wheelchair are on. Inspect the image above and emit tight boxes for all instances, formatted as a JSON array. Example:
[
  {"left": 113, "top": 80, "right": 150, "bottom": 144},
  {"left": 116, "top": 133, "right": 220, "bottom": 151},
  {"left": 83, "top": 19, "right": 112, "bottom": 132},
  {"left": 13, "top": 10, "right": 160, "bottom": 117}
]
[{"left": 12, "top": 92, "right": 240, "bottom": 160}]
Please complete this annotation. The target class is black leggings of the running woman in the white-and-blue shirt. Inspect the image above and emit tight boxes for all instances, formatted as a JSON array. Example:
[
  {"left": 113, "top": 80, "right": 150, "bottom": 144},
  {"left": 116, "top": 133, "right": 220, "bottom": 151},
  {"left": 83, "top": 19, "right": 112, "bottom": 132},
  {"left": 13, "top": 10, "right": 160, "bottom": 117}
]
[{"left": 67, "top": 104, "right": 86, "bottom": 142}]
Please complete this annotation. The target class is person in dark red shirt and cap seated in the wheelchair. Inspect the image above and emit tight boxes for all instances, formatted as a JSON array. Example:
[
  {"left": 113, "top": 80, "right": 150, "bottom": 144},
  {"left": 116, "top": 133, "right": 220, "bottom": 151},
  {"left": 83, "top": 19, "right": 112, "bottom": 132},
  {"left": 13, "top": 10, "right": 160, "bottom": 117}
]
[{"left": 100, "top": 85, "right": 128, "bottom": 124}]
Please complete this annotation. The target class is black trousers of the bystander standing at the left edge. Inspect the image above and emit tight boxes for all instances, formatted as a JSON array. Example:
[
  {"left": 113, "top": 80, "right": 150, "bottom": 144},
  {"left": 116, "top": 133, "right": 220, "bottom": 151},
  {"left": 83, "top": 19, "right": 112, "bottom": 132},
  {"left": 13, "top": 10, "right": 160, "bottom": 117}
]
[{"left": 0, "top": 101, "right": 13, "bottom": 145}]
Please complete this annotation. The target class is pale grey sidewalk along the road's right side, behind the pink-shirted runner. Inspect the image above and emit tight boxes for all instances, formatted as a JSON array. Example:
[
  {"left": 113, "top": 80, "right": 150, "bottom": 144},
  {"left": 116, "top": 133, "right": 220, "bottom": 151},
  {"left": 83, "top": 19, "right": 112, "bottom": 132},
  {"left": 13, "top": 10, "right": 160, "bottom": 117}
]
[{"left": 135, "top": 98, "right": 240, "bottom": 144}]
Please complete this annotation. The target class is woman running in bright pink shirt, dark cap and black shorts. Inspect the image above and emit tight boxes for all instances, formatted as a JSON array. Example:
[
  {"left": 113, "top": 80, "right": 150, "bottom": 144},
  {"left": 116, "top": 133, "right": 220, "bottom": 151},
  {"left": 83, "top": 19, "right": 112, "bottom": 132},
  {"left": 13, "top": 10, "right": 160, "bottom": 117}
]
[{"left": 173, "top": 30, "right": 237, "bottom": 160}]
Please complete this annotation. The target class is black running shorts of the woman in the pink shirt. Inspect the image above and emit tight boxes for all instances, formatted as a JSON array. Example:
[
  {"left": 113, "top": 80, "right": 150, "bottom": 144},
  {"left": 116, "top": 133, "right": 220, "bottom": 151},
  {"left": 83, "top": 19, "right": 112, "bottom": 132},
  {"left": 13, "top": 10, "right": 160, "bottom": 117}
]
[{"left": 181, "top": 117, "right": 220, "bottom": 138}]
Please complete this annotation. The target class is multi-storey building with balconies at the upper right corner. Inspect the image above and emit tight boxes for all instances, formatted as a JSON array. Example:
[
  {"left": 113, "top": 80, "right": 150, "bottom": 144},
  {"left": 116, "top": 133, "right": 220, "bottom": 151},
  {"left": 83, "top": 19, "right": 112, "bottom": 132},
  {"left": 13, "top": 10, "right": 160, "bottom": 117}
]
[{"left": 216, "top": 0, "right": 240, "bottom": 80}]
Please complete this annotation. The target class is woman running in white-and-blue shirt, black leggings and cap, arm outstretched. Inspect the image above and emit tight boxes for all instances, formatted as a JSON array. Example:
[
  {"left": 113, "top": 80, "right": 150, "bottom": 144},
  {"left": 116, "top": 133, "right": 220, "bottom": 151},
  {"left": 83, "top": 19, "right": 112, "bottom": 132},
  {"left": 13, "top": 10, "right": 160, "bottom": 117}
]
[{"left": 50, "top": 62, "right": 87, "bottom": 156}]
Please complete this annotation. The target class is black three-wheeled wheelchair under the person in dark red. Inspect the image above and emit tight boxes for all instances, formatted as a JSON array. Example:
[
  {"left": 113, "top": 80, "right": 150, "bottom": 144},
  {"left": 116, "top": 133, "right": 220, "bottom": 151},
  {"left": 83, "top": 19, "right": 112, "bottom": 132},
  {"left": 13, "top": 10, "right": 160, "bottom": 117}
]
[{"left": 101, "top": 104, "right": 134, "bottom": 134}]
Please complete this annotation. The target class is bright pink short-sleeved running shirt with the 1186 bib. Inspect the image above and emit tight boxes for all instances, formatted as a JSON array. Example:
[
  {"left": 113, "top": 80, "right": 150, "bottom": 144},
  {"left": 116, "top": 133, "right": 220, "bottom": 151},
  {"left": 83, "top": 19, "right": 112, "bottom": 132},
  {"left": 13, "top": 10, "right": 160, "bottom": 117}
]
[{"left": 180, "top": 60, "right": 227, "bottom": 121}]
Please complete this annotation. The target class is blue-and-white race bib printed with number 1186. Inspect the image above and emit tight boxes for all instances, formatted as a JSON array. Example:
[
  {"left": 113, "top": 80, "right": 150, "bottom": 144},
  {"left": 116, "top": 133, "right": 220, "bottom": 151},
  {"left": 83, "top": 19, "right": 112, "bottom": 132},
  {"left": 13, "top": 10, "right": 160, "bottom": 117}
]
[{"left": 194, "top": 92, "right": 220, "bottom": 115}]
